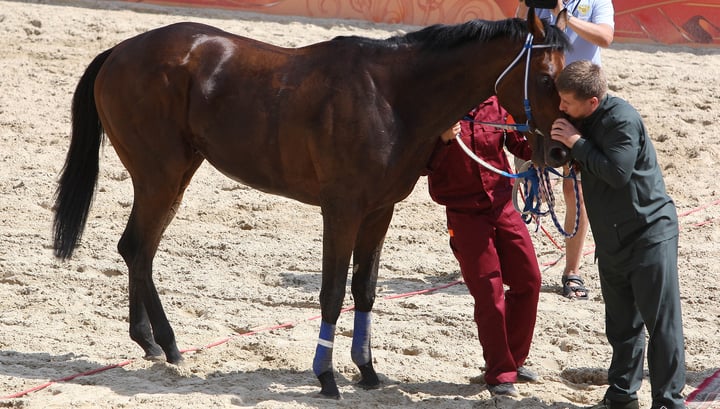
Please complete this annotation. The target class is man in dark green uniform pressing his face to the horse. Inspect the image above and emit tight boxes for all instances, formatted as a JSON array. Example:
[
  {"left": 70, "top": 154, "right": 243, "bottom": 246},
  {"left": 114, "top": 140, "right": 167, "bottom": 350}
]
[{"left": 551, "top": 61, "right": 685, "bottom": 409}]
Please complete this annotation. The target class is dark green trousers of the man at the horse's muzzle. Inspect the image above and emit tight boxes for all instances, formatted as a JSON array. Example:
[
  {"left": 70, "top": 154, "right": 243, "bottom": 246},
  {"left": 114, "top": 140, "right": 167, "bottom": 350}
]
[{"left": 598, "top": 236, "right": 685, "bottom": 409}]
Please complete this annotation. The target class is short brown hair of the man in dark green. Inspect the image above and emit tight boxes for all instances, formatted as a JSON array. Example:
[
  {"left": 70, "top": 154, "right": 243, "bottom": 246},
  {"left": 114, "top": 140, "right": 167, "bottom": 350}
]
[{"left": 555, "top": 60, "right": 607, "bottom": 99}]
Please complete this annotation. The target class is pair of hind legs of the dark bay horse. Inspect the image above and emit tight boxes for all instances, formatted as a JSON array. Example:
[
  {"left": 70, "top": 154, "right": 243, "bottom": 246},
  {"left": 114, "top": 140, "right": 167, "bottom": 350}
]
[{"left": 118, "top": 157, "right": 203, "bottom": 363}]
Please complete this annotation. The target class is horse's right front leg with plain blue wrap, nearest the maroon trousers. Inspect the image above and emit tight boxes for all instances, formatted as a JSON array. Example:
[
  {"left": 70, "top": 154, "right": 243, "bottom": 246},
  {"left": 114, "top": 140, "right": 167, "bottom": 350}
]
[{"left": 351, "top": 205, "right": 394, "bottom": 389}]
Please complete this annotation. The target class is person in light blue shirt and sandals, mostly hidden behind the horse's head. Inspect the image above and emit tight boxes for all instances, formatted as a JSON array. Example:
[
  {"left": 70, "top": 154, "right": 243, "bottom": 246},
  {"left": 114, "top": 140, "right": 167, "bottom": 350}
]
[{"left": 517, "top": 0, "right": 615, "bottom": 300}]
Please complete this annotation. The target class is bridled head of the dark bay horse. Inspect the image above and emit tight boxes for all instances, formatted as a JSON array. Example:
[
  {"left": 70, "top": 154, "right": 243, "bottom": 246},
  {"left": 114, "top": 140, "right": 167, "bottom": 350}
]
[{"left": 495, "top": 8, "right": 570, "bottom": 167}]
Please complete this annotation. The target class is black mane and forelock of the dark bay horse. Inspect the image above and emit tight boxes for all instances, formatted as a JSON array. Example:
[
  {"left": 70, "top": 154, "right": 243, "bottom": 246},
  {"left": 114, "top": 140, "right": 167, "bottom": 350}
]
[{"left": 332, "top": 18, "right": 570, "bottom": 51}]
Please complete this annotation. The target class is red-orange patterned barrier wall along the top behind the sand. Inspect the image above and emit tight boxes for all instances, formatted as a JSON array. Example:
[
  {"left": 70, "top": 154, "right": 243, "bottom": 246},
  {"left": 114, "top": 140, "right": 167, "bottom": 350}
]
[{"left": 125, "top": 0, "right": 720, "bottom": 47}]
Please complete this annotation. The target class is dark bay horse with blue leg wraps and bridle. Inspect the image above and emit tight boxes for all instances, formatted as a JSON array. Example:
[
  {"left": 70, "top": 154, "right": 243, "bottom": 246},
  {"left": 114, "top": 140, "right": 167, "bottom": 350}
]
[{"left": 54, "top": 13, "right": 568, "bottom": 397}]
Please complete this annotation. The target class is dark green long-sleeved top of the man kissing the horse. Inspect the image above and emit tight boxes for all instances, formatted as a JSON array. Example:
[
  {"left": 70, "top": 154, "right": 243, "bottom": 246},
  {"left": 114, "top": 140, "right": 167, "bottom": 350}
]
[{"left": 571, "top": 96, "right": 678, "bottom": 257}]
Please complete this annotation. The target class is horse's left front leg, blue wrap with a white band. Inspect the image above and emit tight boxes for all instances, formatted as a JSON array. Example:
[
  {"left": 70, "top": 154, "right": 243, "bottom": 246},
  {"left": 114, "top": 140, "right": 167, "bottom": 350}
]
[{"left": 313, "top": 205, "right": 359, "bottom": 399}]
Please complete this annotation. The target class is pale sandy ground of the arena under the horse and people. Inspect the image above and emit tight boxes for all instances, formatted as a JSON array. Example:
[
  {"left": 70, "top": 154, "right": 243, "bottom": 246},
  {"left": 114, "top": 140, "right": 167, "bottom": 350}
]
[{"left": 0, "top": 0, "right": 720, "bottom": 409}]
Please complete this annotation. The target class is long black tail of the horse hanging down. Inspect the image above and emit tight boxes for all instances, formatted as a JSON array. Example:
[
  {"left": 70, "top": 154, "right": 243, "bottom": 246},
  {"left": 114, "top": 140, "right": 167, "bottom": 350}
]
[{"left": 53, "top": 48, "right": 113, "bottom": 259}]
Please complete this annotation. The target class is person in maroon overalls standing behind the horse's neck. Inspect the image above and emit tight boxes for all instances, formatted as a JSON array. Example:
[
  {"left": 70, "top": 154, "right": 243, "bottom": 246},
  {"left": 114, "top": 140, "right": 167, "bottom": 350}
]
[{"left": 428, "top": 97, "right": 541, "bottom": 396}]
